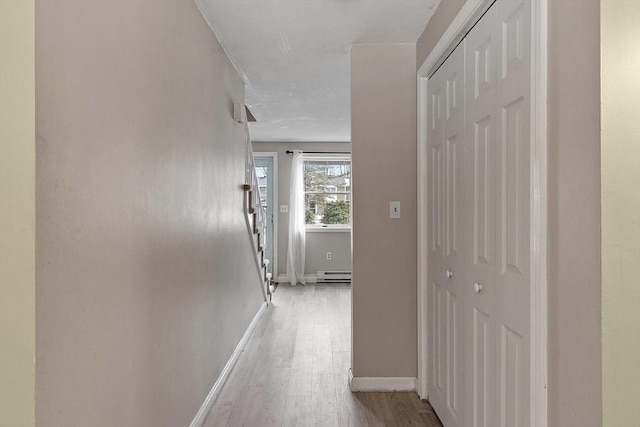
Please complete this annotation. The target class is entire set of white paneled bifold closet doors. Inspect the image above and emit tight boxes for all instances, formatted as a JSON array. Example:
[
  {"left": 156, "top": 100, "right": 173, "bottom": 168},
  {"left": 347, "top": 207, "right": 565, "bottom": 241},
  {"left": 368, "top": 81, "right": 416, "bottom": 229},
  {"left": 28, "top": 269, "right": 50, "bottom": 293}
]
[{"left": 427, "top": 0, "right": 531, "bottom": 427}]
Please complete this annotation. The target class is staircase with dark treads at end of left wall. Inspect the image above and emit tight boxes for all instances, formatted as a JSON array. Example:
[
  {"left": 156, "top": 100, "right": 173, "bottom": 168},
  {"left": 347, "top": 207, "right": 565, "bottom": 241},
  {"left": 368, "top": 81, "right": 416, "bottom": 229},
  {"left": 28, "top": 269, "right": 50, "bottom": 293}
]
[{"left": 242, "top": 129, "right": 273, "bottom": 303}]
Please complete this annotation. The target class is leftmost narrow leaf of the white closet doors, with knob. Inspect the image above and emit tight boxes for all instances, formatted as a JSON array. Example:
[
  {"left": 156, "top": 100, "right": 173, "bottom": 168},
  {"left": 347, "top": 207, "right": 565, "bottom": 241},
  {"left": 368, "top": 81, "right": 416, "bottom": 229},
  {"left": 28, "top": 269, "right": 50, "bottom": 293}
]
[{"left": 427, "top": 39, "right": 465, "bottom": 427}]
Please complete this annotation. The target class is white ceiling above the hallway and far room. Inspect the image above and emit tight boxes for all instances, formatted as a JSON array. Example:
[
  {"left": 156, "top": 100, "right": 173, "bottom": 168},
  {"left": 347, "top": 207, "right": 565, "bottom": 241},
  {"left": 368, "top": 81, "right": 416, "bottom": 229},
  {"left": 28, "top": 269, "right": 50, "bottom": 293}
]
[{"left": 196, "top": 0, "right": 440, "bottom": 141}]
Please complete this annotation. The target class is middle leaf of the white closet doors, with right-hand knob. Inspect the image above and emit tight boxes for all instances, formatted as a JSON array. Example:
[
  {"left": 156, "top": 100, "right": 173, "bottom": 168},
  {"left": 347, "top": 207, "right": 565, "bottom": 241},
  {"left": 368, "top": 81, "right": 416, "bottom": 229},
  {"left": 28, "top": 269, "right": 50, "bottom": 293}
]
[{"left": 464, "top": 5, "right": 499, "bottom": 427}]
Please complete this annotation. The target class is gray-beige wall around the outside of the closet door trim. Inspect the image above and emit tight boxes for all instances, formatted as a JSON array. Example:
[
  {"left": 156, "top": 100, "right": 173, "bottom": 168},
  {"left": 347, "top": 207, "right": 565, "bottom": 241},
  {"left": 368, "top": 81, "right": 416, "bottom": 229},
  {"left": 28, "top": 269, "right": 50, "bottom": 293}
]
[{"left": 417, "top": 0, "right": 602, "bottom": 427}]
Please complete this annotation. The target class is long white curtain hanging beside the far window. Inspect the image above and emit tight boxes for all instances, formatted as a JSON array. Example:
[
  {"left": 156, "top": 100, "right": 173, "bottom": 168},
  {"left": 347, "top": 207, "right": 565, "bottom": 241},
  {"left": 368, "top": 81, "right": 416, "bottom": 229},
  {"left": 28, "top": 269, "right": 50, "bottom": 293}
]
[{"left": 287, "top": 151, "right": 307, "bottom": 285}]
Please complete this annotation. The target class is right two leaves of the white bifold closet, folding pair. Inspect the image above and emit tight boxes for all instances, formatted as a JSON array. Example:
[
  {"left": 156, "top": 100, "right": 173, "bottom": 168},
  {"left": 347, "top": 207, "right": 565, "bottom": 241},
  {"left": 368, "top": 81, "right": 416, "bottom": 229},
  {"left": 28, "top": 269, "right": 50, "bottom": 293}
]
[{"left": 464, "top": 0, "right": 531, "bottom": 427}]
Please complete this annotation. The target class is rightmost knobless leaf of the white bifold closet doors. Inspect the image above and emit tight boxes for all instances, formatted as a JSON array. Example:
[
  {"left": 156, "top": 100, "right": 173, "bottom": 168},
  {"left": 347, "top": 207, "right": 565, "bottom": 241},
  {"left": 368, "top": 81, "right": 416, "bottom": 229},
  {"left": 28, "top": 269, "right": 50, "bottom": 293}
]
[{"left": 493, "top": 0, "right": 531, "bottom": 427}]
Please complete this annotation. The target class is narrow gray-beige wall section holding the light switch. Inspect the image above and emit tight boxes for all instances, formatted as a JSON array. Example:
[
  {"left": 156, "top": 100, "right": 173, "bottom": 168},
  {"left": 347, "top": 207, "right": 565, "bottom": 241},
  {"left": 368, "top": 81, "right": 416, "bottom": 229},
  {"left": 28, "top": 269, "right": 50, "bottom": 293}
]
[{"left": 351, "top": 44, "right": 417, "bottom": 377}]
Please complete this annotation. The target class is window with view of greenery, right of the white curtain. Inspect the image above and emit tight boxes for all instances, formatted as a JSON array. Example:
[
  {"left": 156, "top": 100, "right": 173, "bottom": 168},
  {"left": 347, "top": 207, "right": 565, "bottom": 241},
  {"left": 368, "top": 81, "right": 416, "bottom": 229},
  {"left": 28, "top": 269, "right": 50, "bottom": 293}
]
[{"left": 304, "top": 155, "right": 351, "bottom": 229}]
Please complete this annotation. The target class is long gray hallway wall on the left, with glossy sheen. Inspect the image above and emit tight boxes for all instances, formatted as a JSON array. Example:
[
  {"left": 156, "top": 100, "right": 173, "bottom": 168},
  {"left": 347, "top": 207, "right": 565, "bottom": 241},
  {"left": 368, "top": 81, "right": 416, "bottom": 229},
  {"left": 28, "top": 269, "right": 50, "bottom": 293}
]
[{"left": 36, "top": 0, "right": 262, "bottom": 427}]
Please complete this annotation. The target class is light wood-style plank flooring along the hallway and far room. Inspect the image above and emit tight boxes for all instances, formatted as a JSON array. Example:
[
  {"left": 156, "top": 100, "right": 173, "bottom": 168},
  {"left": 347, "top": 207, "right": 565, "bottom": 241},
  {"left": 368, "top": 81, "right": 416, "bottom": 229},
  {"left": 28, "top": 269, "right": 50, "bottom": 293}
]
[{"left": 205, "top": 283, "right": 442, "bottom": 427}]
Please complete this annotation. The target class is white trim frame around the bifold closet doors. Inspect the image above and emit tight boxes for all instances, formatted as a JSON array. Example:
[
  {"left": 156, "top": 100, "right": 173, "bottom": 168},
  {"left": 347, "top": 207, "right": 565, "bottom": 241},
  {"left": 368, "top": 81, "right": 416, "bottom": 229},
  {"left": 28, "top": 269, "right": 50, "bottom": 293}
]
[{"left": 416, "top": 0, "right": 548, "bottom": 427}]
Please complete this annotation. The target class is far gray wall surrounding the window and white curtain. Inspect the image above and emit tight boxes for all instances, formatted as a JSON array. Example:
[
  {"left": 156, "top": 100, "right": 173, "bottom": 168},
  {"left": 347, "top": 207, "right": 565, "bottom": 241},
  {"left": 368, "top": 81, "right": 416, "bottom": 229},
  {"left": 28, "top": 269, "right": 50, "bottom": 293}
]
[{"left": 253, "top": 142, "right": 351, "bottom": 276}]
